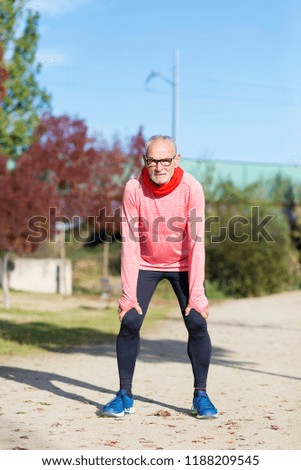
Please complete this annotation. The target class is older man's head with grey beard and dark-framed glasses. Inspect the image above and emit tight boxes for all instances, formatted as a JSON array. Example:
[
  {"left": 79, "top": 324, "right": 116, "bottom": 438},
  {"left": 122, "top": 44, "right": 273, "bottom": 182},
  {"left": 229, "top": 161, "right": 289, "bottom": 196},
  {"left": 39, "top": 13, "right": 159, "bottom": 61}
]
[{"left": 145, "top": 139, "right": 180, "bottom": 185}]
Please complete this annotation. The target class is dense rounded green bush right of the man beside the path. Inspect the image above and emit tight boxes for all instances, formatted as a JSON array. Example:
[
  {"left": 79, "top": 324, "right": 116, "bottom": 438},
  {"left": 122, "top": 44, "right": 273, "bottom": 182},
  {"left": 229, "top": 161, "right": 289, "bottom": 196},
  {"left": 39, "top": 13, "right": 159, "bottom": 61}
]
[{"left": 206, "top": 203, "right": 298, "bottom": 297}]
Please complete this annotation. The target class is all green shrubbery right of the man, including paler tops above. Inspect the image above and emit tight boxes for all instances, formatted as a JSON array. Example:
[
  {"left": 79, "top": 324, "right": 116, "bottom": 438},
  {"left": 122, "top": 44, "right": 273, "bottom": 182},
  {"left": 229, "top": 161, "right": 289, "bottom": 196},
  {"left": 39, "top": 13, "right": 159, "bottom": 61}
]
[{"left": 196, "top": 170, "right": 301, "bottom": 297}]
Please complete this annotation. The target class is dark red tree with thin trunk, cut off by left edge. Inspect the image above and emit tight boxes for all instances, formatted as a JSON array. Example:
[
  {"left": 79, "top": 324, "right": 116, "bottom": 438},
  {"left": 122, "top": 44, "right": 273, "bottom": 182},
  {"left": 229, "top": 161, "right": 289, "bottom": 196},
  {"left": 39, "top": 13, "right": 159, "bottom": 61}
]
[{"left": 0, "top": 154, "right": 53, "bottom": 308}]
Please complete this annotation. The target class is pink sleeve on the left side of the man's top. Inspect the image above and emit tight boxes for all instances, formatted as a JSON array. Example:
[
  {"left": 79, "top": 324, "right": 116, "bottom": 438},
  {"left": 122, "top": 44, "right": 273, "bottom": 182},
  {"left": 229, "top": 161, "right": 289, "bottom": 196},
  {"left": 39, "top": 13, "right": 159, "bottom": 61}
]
[{"left": 119, "top": 180, "right": 140, "bottom": 311}]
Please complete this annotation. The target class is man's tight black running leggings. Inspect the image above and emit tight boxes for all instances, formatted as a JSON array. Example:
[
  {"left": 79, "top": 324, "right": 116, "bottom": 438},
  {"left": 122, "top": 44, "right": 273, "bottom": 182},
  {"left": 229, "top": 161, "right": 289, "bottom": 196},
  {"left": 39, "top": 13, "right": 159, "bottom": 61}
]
[{"left": 116, "top": 270, "right": 211, "bottom": 392}]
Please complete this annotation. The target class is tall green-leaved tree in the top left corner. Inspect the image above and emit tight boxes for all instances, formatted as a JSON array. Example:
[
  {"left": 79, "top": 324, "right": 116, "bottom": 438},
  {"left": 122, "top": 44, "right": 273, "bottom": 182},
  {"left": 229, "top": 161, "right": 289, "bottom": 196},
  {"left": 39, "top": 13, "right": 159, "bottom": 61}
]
[{"left": 0, "top": 0, "right": 49, "bottom": 160}]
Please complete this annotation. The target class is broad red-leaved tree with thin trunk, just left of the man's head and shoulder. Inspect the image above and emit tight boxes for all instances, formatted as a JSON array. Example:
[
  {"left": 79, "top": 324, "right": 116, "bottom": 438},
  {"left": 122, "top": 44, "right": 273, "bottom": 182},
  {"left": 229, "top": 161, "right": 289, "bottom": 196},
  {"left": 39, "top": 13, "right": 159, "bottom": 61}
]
[{"left": 23, "top": 114, "right": 144, "bottom": 290}]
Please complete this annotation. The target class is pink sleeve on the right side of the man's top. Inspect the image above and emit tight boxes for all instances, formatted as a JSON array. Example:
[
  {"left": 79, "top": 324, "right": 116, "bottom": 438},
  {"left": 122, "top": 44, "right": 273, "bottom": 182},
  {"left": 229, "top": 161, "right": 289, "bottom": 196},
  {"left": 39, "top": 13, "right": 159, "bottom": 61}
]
[{"left": 187, "top": 183, "right": 208, "bottom": 312}]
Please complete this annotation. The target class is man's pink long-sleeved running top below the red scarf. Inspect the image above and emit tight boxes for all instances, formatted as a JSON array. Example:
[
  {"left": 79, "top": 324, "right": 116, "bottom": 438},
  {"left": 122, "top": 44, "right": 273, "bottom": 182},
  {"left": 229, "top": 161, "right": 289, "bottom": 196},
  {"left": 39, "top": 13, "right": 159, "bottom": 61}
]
[{"left": 119, "top": 172, "right": 208, "bottom": 312}]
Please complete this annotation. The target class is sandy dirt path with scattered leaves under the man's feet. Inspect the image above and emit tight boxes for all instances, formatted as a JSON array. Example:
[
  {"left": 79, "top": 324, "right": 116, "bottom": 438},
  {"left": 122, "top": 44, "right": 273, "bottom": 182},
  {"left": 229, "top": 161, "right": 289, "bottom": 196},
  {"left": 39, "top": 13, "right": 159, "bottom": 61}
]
[{"left": 0, "top": 291, "right": 301, "bottom": 450}]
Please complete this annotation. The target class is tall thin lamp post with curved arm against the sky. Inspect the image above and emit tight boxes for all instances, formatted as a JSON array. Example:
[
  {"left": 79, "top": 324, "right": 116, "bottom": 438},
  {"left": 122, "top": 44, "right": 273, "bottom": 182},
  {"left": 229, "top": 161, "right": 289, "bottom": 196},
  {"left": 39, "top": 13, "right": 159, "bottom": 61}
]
[{"left": 145, "top": 49, "right": 179, "bottom": 141}]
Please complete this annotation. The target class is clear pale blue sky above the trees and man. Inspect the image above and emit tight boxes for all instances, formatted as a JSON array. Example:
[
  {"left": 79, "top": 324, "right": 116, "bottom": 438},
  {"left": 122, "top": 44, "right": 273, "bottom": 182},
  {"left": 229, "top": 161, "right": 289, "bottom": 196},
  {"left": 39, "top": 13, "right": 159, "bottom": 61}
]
[{"left": 27, "top": 0, "right": 301, "bottom": 164}]
